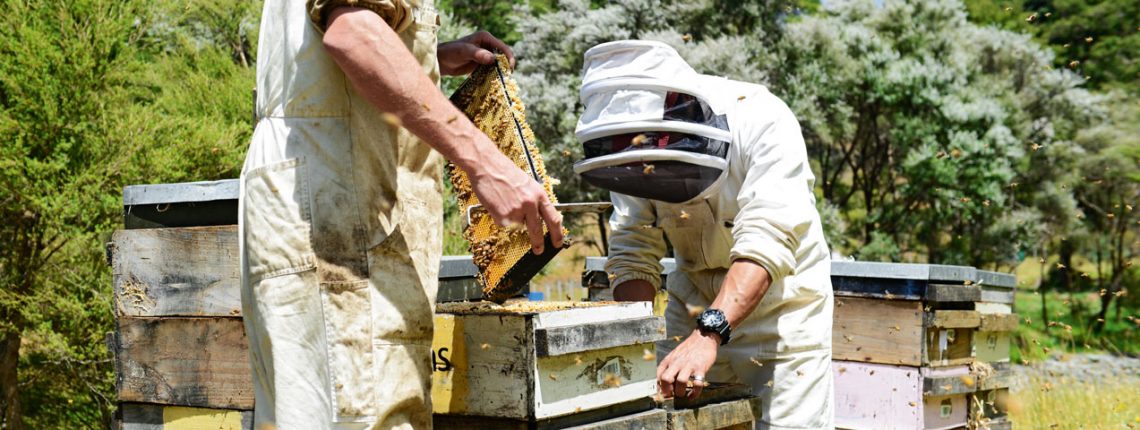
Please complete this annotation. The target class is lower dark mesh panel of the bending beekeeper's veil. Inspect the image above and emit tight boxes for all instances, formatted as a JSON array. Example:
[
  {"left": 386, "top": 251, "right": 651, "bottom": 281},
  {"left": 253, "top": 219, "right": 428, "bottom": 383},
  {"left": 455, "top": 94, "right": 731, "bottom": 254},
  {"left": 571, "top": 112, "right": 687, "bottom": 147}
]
[{"left": 581, "top": 161, "right": 720, "bottom": 203}]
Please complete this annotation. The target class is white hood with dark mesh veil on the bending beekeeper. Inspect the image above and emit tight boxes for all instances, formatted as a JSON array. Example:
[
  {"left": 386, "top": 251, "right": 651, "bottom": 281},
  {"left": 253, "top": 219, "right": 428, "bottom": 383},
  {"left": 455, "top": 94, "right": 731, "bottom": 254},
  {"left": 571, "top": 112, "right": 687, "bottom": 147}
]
[{"left": 573, "top": 40, "right": 732, "bottom": 203}]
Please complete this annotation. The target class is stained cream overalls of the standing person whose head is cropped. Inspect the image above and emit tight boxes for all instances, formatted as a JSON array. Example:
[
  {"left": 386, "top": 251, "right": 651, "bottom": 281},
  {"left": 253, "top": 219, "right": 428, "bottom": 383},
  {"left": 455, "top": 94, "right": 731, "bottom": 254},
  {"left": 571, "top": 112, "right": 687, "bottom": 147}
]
[{"left": 239, "top": 0, "right": 442, "bottom": 430}]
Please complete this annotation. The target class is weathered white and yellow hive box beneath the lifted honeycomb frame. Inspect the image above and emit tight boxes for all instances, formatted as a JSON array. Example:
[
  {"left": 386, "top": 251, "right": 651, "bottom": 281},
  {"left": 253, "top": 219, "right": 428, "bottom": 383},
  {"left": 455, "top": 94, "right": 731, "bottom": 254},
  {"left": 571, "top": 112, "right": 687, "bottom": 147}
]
[{"left": 432, "top": 301, "right": 665, "bottom": 428}]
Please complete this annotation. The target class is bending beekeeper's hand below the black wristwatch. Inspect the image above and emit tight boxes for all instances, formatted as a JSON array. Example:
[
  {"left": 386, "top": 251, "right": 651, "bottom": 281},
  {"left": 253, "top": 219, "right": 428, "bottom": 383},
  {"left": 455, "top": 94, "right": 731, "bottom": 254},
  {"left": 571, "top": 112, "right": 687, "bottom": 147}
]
[{"left": 657, "top": 330, "right": 720, "bottom": 398}]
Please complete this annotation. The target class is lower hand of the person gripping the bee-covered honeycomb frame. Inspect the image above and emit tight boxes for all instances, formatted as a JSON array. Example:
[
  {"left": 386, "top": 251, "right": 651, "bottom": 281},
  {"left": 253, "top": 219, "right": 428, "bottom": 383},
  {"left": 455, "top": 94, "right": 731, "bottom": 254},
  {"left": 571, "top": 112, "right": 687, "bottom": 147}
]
[{"left": 467, "top": 152, "right": 562, "bottom": 254}]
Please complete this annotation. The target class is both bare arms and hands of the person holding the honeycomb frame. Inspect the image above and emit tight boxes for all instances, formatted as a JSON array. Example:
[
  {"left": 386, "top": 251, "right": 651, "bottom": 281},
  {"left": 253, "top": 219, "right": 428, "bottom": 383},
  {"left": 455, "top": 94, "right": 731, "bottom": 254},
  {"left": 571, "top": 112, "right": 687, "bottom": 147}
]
[{"left": 310, "top": 4, "right": 562, "bottom": 252}]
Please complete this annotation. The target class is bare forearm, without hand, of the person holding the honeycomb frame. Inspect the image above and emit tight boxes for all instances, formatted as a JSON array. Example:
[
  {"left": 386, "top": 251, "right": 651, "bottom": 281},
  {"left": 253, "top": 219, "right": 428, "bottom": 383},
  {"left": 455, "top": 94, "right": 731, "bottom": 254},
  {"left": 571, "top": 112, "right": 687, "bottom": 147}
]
[{"left": 324, "top": 7, "right": 497, "bottom": 172}]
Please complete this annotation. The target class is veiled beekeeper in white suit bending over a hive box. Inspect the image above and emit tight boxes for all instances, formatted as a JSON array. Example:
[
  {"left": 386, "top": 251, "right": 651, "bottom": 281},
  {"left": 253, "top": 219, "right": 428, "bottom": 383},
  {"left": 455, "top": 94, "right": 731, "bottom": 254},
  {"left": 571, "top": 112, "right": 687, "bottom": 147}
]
[{"left": 575, "top": 41, "right": 834, "bottom": 429}]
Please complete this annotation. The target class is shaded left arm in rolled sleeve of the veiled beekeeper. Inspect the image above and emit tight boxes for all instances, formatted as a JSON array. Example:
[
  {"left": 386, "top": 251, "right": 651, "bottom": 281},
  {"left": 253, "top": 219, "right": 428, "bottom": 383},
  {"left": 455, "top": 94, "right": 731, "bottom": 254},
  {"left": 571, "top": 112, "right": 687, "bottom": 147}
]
[{"left": 605, "top": 193, "right": 665, "bottom": 301}]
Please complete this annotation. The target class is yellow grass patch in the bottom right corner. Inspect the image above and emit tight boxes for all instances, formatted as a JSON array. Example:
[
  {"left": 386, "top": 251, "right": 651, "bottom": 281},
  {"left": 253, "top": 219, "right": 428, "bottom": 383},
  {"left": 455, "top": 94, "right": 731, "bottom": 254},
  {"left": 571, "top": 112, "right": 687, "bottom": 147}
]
[{"left": 1008, "top": 378, "right": 1140, "bottom": 429}]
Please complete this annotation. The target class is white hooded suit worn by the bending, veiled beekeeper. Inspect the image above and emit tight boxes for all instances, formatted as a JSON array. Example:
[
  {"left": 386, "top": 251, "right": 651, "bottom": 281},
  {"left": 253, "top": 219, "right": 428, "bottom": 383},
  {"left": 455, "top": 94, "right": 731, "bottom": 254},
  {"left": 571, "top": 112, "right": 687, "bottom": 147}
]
[{"left": 578, "top": 41, "right": 833, "bottom": 429}]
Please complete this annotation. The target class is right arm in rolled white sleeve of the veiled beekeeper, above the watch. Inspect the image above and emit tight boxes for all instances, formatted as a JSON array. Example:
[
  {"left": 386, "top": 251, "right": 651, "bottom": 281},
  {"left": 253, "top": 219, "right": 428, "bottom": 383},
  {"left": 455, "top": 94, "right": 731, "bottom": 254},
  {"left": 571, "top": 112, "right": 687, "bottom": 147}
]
[{"left": 711, "top": 90, "right": 819, "bottom": 327}]
